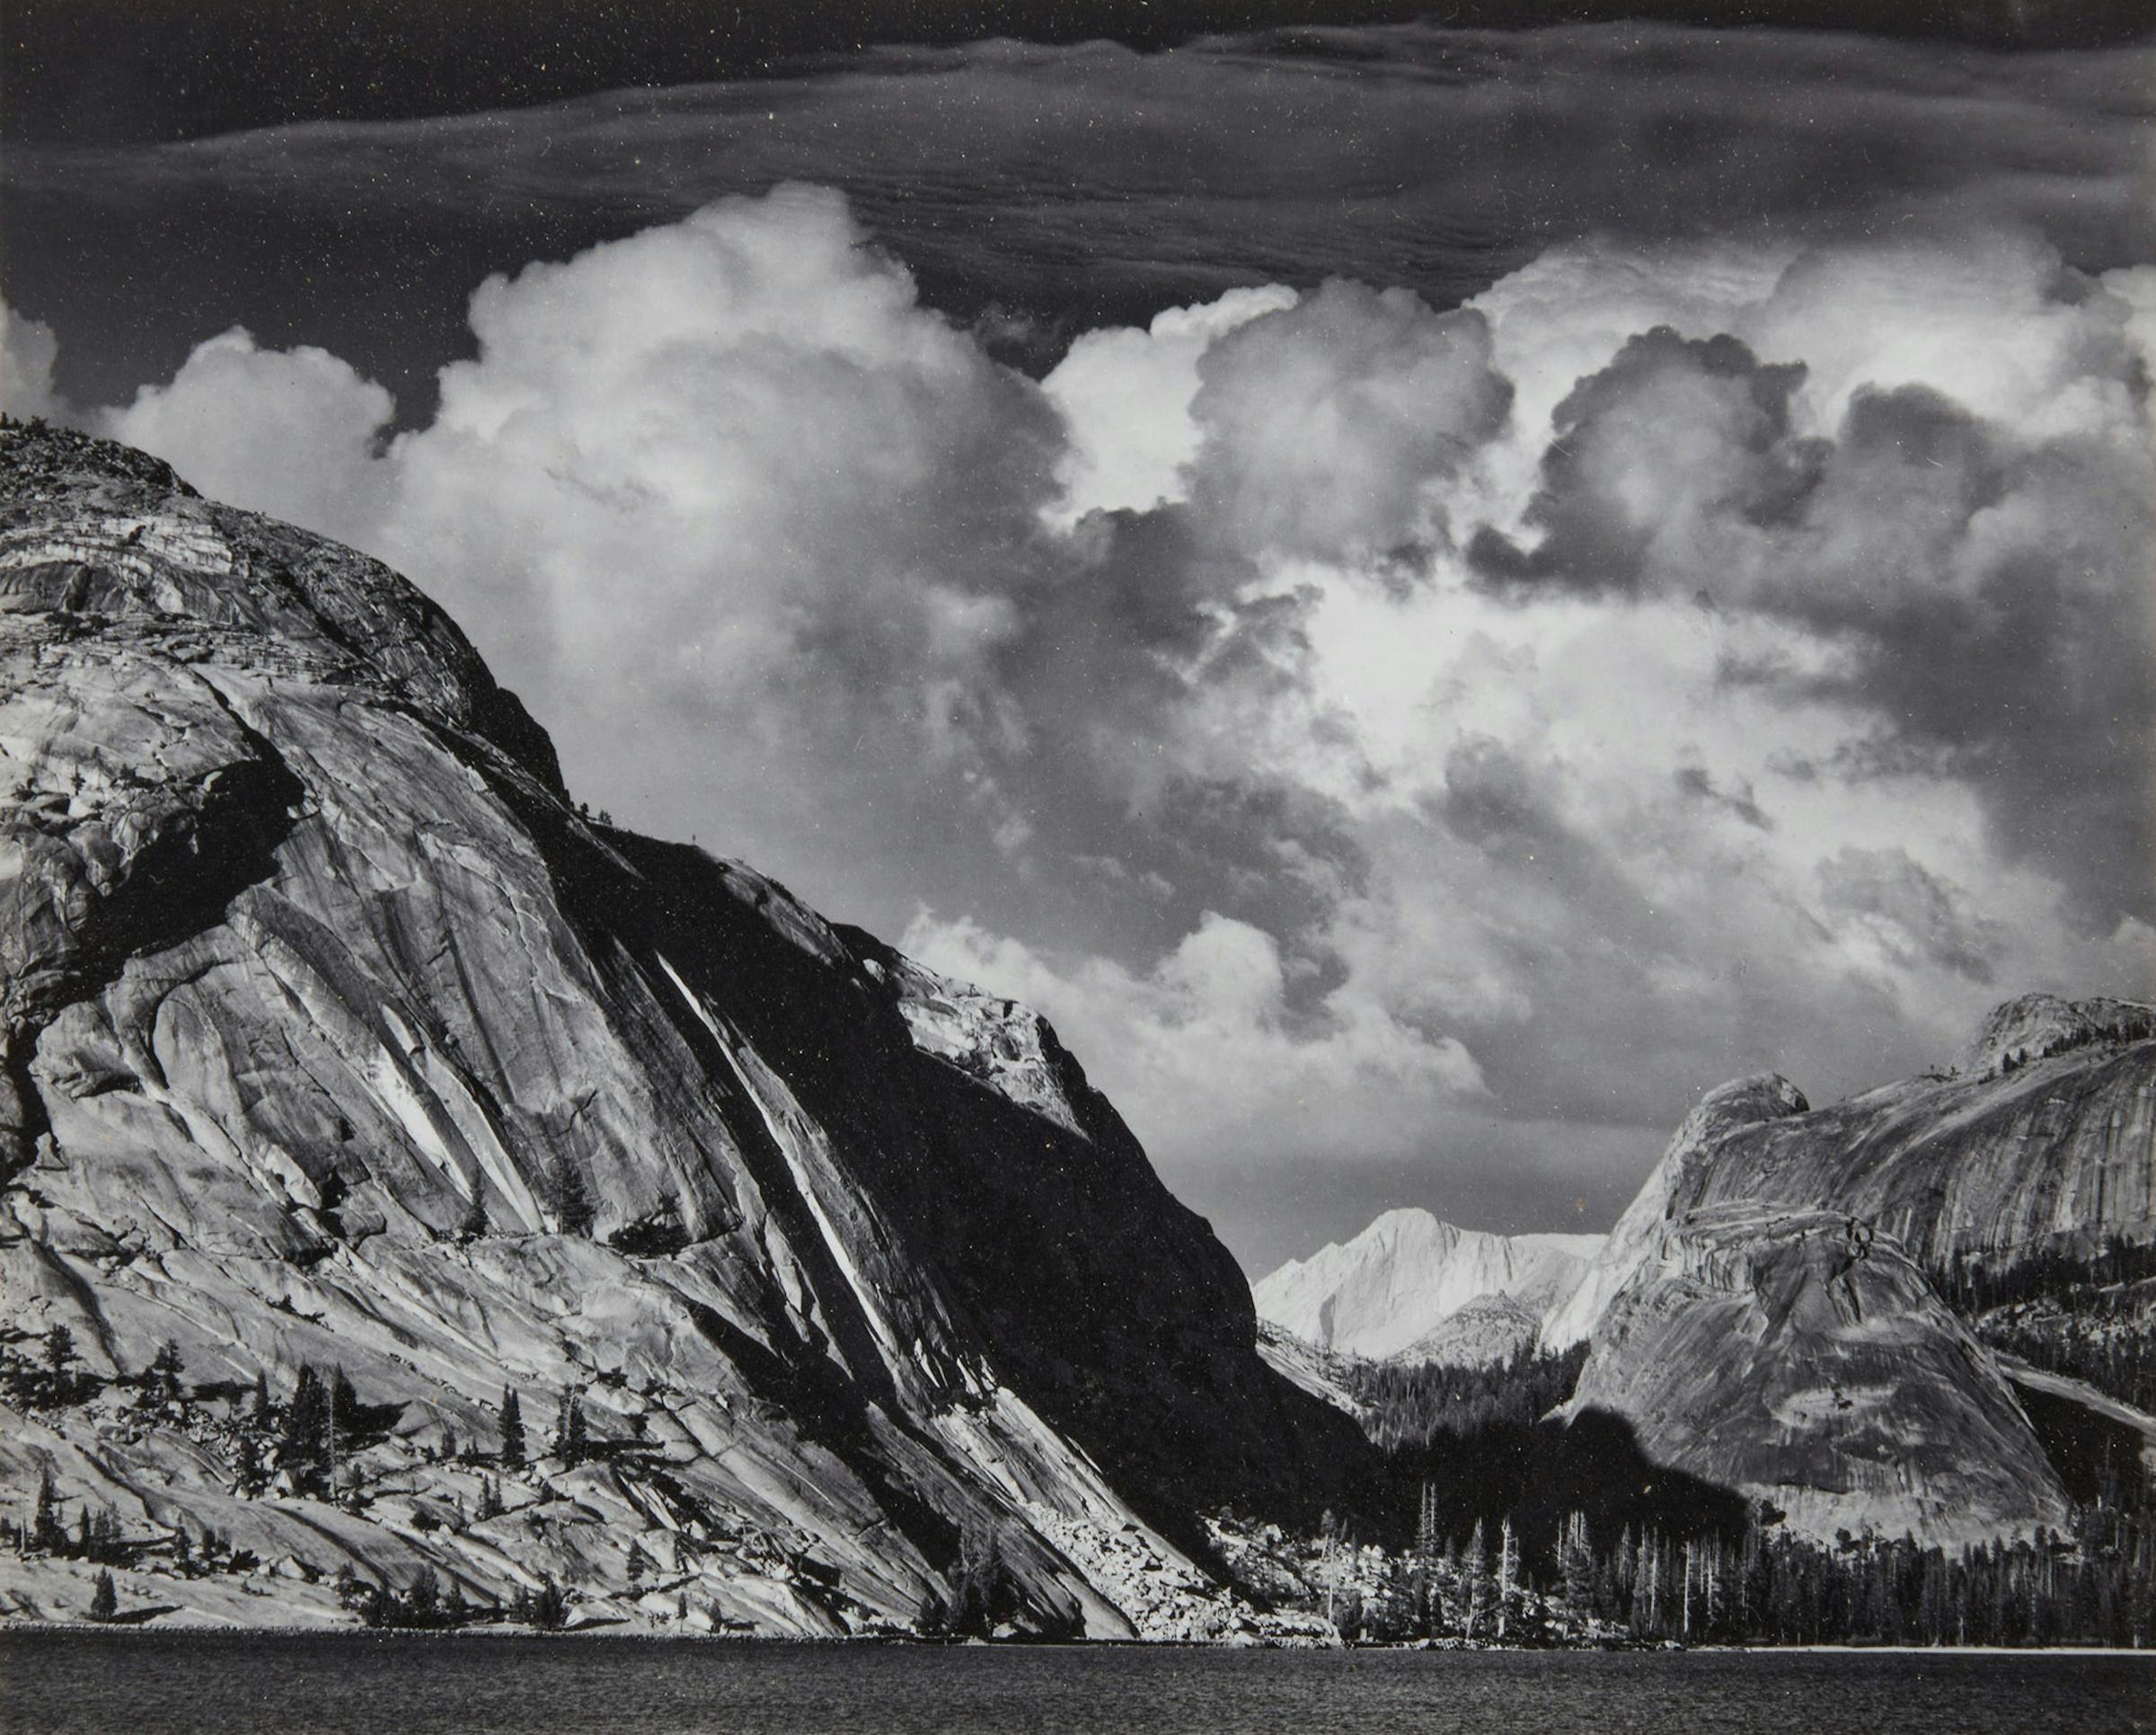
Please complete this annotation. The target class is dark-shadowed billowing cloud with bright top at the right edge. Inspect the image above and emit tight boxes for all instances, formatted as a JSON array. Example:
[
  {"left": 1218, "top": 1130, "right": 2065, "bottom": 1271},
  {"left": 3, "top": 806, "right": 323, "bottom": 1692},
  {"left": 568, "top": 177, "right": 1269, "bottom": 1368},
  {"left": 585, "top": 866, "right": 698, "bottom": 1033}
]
[{"left": 1475, "top": 237, "right": 2156, "bottom": 929}]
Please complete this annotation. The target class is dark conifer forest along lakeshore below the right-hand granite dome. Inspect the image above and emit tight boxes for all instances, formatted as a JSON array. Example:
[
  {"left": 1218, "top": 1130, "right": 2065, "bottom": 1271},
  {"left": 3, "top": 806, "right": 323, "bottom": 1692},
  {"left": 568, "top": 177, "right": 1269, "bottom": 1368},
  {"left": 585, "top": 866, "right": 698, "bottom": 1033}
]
[{"left": 1294, "top": 1319, "right": 2156, "bottom": 1644}]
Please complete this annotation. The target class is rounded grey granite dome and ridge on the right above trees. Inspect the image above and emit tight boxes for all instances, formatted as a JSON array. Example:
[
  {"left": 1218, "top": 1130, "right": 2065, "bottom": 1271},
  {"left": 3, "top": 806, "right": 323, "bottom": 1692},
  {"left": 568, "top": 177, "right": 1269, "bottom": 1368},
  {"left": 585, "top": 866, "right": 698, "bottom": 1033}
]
[{"left": 1543, "top": 996, "right": 2156, "bottom": 1544}]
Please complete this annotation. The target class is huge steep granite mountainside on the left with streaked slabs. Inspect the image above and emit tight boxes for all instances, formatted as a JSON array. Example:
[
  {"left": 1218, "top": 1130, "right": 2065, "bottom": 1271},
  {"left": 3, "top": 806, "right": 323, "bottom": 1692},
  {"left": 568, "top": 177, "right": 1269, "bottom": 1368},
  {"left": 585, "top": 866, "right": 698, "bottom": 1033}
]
[{"left": 0, "top": 429, "right": 1365, "bottom": 1633}]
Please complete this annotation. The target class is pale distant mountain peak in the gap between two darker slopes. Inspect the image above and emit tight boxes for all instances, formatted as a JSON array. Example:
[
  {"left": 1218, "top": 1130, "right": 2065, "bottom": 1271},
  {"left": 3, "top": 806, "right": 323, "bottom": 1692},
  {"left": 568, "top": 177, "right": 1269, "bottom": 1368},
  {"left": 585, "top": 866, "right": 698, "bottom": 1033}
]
[{"left": 1250, "top": 1209, "right": 1602, "bottom": 1360}]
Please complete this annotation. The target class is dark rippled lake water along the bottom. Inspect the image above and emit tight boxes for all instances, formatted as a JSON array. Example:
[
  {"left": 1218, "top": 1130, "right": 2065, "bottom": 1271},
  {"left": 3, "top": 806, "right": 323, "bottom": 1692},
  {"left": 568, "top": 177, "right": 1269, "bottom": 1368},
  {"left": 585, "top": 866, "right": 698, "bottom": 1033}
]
[{"left": 0, "top": 1632, "right": 2156, "bottom": 1735}]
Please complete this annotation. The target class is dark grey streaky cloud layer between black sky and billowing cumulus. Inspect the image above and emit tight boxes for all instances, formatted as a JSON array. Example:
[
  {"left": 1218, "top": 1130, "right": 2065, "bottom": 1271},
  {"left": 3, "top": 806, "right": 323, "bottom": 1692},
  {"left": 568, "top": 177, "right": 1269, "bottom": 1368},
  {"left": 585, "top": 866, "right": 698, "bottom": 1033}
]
[{"left": 0, "top": 23, "right": 2156, "bottom": 409}]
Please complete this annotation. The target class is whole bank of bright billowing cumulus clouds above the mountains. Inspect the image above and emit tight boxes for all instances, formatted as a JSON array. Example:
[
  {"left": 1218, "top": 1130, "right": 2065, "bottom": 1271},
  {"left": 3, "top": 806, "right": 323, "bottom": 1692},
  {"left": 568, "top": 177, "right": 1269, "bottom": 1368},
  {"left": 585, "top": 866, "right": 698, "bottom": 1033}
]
[{"left": 38, "top": 188, "right": 2156, "bottom": 1248}]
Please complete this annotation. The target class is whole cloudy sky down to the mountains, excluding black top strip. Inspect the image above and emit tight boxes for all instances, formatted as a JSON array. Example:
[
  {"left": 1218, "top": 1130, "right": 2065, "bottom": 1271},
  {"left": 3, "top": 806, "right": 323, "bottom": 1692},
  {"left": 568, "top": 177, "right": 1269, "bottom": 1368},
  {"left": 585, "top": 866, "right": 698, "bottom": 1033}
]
[{"left": 0, "top": 4, "right": 2156, "bottom": 1270}]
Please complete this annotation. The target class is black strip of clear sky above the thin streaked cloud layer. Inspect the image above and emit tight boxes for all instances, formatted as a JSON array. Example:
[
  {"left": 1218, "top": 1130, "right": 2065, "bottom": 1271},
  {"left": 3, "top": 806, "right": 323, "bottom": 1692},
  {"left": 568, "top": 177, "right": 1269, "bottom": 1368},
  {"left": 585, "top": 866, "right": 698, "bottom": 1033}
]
[{"left": 0, "top": 0, "right": 2156, "bottom": 142}]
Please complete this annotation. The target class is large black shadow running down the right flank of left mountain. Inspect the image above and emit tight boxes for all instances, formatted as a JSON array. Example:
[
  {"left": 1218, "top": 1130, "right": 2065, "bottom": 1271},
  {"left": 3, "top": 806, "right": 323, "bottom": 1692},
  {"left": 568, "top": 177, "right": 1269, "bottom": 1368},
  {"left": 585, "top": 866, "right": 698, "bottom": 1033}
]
[{"left": 450, "top": 776, "right": 1380, "bottom": 1552}]
